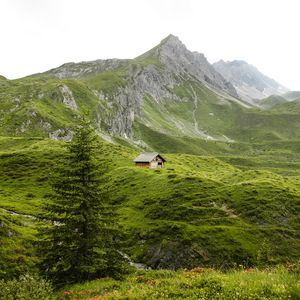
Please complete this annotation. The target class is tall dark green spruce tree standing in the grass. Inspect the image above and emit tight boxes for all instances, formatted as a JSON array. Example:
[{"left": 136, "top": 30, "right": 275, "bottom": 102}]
[{"left": 39, "top": 119, "right": 125, "bottom": 284}]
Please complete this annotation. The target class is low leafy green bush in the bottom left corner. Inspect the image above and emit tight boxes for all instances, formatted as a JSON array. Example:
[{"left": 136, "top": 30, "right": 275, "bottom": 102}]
[{"left": 0, "top": 275, "right": 52, "bottom": 300}]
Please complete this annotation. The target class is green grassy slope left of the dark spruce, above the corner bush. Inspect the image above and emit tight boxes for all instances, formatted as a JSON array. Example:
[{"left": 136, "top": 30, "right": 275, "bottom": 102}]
[{"left": 0, "top": 137, "right": 132, "bottom": 279}]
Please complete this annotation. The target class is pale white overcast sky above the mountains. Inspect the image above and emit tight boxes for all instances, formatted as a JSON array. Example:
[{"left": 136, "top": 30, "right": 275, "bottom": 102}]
[{"left": 0, "top": 0, "right": 300, "bottom": 90}]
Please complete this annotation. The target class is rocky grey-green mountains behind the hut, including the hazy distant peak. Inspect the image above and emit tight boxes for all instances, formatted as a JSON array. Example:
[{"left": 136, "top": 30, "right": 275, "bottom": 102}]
[{"left": 0, "top": 35, "right": 300, "bottom": 152}]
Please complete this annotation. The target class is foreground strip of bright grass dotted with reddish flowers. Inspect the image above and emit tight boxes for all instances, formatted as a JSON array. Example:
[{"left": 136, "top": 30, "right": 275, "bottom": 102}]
[{"left": 56, "top": 268, "right": 300, "bottom": 300}]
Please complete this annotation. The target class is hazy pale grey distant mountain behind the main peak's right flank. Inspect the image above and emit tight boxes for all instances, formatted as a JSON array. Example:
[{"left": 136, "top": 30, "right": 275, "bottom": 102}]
[{"left": 213, "top": 60, "right": 288, "bottom": 104}]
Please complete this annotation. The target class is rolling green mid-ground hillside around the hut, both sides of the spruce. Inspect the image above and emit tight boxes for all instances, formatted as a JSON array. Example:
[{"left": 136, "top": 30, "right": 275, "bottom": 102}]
[{"left": 0, "top": 137, "right": 300, "bottom": 280}]
